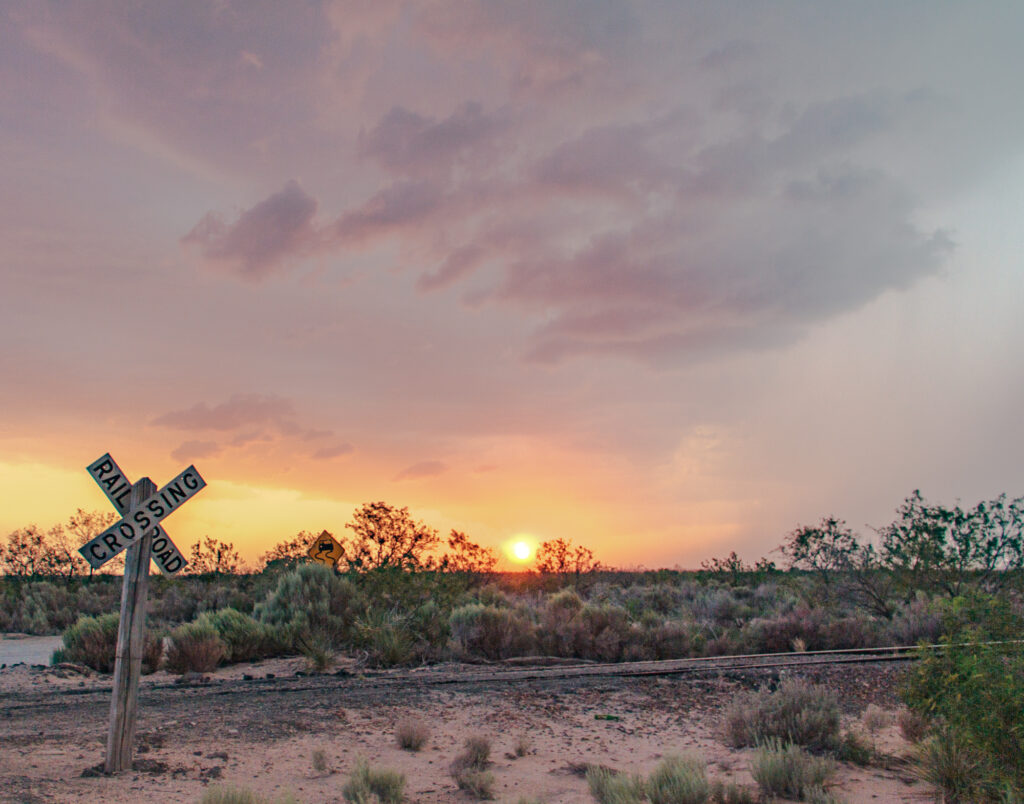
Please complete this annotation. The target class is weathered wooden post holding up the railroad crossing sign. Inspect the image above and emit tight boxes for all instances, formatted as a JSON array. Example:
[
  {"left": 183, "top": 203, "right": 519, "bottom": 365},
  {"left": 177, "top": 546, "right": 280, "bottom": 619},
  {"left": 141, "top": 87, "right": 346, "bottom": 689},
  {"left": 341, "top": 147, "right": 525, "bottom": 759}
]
[{"left": 103, "top": 477, "right": 157, "bottom": 773}]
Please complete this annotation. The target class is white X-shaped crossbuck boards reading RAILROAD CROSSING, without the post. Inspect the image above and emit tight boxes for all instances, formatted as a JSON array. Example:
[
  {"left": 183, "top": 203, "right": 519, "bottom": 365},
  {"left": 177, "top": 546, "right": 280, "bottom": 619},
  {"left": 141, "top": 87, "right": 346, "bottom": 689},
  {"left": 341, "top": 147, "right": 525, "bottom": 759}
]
[{"left": 79, "top": 453, "right": 206, "bottom": 575}]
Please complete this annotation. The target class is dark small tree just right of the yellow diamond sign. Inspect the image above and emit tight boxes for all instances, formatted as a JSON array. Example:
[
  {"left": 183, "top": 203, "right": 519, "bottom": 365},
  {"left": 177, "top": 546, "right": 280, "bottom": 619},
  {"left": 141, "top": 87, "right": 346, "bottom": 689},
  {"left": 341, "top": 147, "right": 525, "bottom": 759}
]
[{"left": 342, "top": 502, "right": 439, "bottom": 573}]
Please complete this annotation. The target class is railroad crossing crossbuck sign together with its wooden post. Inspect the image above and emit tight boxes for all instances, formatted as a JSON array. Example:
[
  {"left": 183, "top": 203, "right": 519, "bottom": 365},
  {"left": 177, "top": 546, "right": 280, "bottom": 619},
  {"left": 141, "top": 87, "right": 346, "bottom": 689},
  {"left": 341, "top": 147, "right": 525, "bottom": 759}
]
[{"left": 79, "top": 454, "right": 206, "bottom": 773}]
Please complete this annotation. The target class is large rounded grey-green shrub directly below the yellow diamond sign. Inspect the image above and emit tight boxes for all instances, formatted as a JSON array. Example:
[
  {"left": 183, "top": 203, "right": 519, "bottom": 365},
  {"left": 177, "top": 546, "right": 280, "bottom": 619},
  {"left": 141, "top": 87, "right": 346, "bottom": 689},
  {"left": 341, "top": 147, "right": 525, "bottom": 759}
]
[{"left": 255, "top": 564, "right": 356, "bottom": 650}]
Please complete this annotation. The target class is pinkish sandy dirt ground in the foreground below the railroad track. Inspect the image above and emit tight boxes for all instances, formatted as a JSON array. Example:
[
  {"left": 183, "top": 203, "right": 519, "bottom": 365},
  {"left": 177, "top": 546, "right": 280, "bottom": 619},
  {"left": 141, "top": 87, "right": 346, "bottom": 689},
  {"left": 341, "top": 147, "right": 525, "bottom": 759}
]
[{"left": 0, "top": 660, "right": 933, "bottom": 804}]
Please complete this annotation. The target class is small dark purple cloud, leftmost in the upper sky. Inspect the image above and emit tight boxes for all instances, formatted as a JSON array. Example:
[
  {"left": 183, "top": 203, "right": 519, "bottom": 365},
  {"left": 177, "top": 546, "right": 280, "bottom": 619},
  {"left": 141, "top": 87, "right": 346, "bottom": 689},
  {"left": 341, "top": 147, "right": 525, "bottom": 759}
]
[{"left": 181, "top": 180, "right": 316, "bottom": 281}]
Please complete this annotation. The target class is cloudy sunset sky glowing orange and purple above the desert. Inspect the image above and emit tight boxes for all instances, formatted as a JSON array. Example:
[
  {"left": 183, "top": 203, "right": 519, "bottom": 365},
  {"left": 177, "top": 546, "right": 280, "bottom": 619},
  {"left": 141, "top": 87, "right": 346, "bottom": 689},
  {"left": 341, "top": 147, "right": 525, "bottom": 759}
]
[{"left": 0, "top": 0, "right": 1024, "bottom": 567}]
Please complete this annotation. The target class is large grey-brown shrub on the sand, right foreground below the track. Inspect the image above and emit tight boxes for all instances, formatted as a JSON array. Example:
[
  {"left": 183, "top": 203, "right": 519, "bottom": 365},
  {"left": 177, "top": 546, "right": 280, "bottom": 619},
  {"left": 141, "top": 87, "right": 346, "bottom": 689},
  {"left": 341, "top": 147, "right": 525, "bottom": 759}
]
[{"left": 722, "top": 680, "right": 840, "bottom": 749}]
